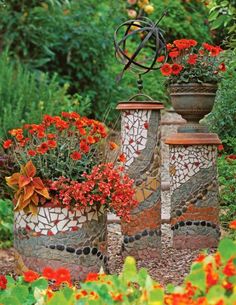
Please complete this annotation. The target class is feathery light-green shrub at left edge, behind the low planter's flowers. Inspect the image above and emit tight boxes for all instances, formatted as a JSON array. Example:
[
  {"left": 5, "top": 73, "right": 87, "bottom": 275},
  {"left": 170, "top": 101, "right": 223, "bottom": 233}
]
[{"left": 0, "top": 52, "right": 91, "bottom": 138}]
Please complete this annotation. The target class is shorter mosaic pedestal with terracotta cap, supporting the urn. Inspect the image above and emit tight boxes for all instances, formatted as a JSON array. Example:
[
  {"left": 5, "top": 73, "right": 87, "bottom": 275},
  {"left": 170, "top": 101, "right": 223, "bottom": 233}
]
[{"left": 166, "top": 133, "right": 221, "bottom": 249}]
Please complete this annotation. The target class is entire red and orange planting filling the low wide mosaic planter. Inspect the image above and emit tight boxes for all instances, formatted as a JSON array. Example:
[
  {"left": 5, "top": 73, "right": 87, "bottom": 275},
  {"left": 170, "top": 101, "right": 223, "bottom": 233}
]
[{"left": 3, "top": 112, "right": 136, "bottom": 219}]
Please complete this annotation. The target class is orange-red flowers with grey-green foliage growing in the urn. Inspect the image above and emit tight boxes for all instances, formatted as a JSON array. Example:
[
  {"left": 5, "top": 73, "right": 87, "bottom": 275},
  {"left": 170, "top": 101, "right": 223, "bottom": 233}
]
[{"left": 157, "top": 39, "right": 226, "bottom": 83}]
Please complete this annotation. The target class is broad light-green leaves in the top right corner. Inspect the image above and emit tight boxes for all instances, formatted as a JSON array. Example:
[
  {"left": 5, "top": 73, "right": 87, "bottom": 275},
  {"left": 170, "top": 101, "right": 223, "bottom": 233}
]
[{"left": 209, "top": 0, "right": 236, "bottom": 49}]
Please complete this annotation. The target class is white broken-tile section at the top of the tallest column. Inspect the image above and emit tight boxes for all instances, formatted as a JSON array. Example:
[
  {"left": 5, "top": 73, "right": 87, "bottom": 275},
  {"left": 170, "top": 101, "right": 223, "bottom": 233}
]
[{"left": 121, "top": 110, "right": 151, "bottom": 168}]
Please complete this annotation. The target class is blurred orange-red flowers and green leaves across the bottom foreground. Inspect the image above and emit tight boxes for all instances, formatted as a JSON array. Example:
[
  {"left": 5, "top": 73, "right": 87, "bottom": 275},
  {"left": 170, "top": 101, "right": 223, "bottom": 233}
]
[{"left": 0, "top": 235, "right": 236, "bottom": 305}]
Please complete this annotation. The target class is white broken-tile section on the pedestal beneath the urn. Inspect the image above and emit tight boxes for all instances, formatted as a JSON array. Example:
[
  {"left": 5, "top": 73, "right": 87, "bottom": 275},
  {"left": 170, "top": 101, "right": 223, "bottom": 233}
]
[{"left": 170, "top": 145, "right": 217, "bottom": 191}]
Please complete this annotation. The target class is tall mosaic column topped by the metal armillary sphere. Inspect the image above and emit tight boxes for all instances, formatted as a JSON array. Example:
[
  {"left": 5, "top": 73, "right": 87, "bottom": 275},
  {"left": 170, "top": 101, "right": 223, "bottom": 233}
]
[{"left": 117, "top": 101, "right": 164, "bottom": 259}]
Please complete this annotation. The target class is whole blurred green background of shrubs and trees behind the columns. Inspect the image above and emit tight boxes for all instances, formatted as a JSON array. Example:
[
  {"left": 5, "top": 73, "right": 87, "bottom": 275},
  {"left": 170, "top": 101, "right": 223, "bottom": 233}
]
[{"left": 0, "top": 0, "right": 236, "bottom": 246}]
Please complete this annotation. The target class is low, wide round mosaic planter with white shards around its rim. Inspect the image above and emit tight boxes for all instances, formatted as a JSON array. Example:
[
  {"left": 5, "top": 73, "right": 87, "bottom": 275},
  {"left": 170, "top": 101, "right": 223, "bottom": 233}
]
[{"left": 14, "top": 207, "right": 107, "bottom": 280}]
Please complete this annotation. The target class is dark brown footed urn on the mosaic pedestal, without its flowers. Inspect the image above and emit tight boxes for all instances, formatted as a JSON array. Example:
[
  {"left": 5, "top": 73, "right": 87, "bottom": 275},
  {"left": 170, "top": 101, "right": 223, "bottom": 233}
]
[{"left": 169, "top": 83, "right": 217, "bottom": 133}]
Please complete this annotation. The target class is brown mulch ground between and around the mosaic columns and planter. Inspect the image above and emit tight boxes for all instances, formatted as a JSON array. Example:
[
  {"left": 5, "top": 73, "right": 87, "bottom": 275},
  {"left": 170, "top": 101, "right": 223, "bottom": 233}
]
[{"left": 0, "top": 223, "right": 215, "bottom": 286}]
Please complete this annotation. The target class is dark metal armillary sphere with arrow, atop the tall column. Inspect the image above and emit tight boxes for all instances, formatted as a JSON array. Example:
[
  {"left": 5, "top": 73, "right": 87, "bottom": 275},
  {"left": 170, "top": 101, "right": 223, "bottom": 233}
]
[{"left": 114, "top": 13, "right": 167, "bottom": 81}]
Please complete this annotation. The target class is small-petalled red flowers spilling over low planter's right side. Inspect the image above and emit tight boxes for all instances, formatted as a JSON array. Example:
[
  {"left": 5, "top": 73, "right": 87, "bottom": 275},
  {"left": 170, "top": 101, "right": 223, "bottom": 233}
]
[{"left": 47, "top": 163, "right": 137, "bottom": 221}]
